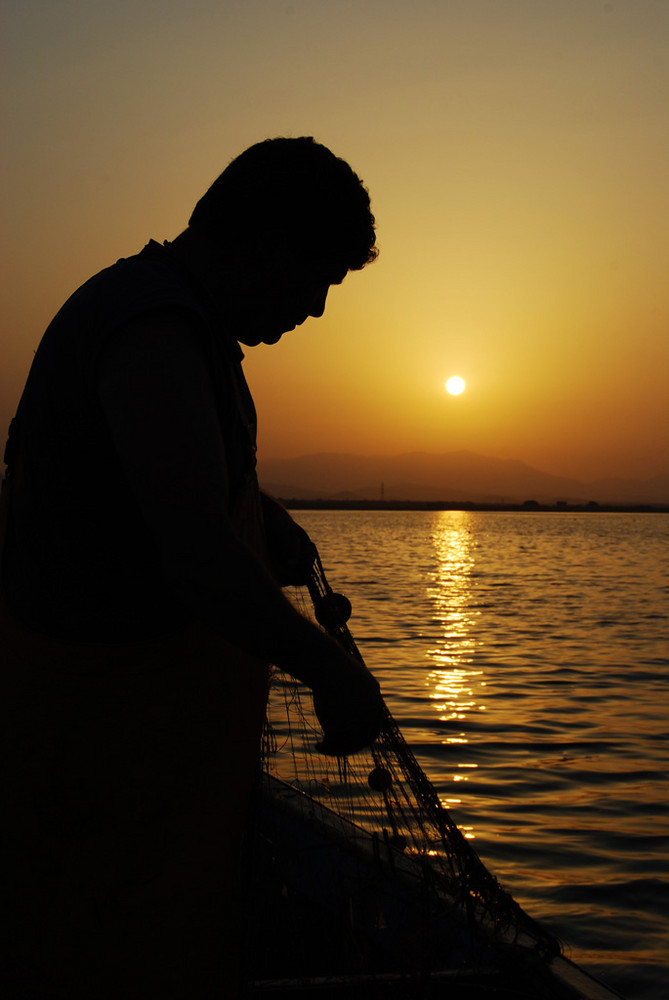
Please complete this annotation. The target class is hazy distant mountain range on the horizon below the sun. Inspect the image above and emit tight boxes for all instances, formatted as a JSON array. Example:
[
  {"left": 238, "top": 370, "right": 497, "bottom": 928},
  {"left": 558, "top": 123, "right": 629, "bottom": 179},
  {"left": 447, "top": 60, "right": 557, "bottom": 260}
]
[{"left": 258, "top": 451, "right": 669, "bottom": 504}]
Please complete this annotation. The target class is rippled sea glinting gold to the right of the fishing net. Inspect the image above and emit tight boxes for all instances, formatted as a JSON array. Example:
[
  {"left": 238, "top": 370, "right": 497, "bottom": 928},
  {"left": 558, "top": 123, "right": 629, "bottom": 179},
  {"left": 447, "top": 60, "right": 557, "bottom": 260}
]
[{"left": 294, "top": 511, "right": 669, "bottom": 1000}]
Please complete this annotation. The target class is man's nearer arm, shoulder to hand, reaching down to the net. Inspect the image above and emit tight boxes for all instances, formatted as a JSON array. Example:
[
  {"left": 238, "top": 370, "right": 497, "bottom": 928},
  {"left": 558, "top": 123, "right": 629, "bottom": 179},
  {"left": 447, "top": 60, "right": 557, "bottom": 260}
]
[{"left": 97, "top": 312, "right": 380, "bottom": 752}]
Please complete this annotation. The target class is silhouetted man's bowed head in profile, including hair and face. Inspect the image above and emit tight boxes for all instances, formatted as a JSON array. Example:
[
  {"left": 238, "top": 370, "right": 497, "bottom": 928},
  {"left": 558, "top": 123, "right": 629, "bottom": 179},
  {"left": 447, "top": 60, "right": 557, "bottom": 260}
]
[{"left": 189, "top": 137, "right": 378, "bottom": 344}]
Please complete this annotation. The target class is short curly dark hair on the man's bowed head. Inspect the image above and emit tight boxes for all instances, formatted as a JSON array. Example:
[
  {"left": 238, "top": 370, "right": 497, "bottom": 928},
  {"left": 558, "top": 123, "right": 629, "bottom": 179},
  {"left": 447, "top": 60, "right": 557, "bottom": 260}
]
[{"left": 189, "top": 136, "right": 378, "bottom": 271}]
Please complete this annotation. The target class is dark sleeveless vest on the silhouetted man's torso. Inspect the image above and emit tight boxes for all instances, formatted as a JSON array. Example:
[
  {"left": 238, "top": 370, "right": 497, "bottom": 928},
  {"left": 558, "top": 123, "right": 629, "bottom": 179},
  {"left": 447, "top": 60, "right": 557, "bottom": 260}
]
[{"left": 3, "top": 241, "right": 255, "bottom": 642}]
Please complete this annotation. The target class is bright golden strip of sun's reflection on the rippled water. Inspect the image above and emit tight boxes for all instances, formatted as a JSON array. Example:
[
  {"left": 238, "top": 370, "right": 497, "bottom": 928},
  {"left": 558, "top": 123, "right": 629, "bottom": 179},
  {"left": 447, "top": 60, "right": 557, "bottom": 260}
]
[{"left": 426, "top": 512, "right": 486, "bottom": 839}]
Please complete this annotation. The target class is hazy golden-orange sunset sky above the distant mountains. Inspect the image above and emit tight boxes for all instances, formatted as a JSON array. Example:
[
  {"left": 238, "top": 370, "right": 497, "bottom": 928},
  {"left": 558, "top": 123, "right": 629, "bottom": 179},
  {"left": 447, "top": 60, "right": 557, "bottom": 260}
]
[{"left": 0, "top": 0, "right": 669, "bottom": 478}]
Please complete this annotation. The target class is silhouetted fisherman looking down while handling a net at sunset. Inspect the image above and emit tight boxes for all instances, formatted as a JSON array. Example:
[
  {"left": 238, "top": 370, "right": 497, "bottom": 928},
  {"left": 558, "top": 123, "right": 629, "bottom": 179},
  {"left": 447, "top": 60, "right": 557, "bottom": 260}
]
[{"left": 0, "top": 138, "right": 381, "bottom": 1000}]
